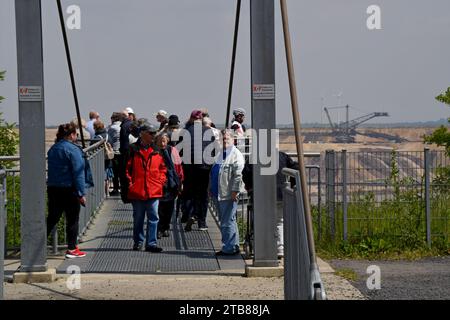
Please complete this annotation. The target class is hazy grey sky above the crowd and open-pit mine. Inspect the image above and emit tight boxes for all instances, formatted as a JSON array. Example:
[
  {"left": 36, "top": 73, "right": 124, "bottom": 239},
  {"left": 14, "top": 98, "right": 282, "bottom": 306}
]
[{"left": 0, "top": 0, "right": 450, "bottom": 125}]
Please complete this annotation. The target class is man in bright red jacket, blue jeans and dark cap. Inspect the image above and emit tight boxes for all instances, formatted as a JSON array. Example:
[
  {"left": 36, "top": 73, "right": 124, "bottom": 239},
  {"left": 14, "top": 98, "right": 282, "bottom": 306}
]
[{"left": 126, "top": 123, "right": 167, "bottom": 253}]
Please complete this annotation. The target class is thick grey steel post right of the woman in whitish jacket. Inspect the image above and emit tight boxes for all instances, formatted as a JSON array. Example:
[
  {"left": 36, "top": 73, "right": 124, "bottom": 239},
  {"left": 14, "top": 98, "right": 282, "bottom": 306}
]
[{"left": 250, "top": 0, "right": 278, "bottom": 267}]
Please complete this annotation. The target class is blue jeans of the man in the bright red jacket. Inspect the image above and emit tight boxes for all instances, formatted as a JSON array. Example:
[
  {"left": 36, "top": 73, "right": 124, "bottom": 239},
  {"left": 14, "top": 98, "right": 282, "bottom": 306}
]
[{"left": 132, "top": 199, "right": 159, "bottom": 247}]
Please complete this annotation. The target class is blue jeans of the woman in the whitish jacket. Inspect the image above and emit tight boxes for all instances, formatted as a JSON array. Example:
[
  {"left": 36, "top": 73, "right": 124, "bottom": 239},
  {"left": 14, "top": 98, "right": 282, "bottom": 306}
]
[{"left": 215, "top": 199, "right": 239, "bottom": 253}]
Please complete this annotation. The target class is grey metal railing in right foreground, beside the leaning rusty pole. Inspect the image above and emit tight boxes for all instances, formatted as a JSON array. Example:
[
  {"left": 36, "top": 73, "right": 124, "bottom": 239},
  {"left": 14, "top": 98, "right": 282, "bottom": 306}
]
[{"left": 283, "top": 168, "right": 326, "bottom": 300}]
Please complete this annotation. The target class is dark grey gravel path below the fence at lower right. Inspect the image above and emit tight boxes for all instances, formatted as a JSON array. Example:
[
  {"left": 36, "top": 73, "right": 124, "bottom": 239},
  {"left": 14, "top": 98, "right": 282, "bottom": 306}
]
[{"left": 329, "top": 256, "right": 450, "bottom": 300}]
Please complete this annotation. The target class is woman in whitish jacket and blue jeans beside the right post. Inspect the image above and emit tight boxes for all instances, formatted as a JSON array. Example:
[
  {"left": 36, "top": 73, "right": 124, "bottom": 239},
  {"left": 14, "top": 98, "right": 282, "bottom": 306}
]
[{"left": 209, "top": 130, "right": 245, "bottom": 255}]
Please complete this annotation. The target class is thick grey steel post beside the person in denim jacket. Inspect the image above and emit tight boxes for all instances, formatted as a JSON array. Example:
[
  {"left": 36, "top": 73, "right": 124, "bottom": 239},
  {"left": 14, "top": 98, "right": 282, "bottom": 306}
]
[{"left": 15, "top": 0, "right": 47, "bottom": 272}]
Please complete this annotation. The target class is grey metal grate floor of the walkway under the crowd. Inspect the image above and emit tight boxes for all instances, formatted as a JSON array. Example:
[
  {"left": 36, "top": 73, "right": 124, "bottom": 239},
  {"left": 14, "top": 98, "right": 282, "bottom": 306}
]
[{"left": 85, "top": 204, "right": 219, "bottom": 273}]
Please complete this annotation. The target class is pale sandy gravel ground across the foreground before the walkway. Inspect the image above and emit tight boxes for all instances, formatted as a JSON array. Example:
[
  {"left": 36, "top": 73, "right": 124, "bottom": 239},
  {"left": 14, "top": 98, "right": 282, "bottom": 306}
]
[{"left": 1, "top": 260, "right": 364, "bottom": 300}]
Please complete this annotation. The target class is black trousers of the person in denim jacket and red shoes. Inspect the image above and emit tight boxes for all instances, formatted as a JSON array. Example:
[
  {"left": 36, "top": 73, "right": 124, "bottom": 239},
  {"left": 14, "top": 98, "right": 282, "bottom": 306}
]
[{"left": 47, "top": 187, "right": 80, "bottom": 250}]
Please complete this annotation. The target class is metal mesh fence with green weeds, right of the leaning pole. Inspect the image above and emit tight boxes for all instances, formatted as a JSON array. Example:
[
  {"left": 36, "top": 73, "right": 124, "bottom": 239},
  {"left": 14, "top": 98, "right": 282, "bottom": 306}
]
[{"left": 326, "top": 150, "right": 450, "bottom": 243}]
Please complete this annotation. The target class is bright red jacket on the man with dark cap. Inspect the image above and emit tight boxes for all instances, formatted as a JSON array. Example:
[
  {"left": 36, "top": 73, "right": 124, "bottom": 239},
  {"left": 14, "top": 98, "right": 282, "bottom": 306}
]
[{"left": 126, "top": 144, "right": 167, "bottom": 200}]
